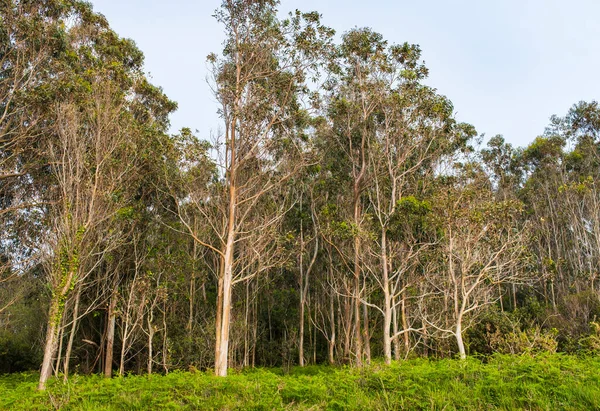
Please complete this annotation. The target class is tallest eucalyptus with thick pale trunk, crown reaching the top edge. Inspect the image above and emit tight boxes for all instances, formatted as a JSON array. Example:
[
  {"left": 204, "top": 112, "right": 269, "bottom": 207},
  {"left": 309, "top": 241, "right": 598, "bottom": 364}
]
[{"left": 173, "top": 0, "right": 333, "bottom": 376}]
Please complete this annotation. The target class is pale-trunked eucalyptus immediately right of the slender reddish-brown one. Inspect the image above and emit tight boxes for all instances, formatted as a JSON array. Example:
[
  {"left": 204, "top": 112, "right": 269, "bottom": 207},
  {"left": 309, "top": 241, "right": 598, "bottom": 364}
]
[{"left": 360, "top": 44, "right": 474, "bottom": 363}]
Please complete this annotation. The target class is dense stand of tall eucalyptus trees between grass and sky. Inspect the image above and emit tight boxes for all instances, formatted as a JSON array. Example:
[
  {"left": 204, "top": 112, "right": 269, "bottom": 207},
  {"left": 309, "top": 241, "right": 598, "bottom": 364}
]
[{"left": 0, "top": 0, "right": 600, "bottom": 390}]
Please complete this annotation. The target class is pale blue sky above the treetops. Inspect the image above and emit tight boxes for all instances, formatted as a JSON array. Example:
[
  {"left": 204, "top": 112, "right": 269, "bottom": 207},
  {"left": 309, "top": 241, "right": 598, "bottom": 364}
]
[{"left": 91, "top": 0, "right": 600, "bottom": 146}]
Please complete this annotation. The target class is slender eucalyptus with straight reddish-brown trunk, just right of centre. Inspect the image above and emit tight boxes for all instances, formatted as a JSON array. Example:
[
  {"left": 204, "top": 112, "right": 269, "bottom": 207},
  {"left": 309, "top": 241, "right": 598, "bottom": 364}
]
[{"left": 323, "top": 29, "right": 389, "bottom": 366}]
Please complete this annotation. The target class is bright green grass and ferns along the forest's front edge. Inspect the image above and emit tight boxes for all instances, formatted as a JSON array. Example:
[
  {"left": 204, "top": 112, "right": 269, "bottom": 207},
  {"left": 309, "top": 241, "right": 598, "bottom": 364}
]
[{"left": 0, "top": 355, "right": 600, "bottom": 410}]
